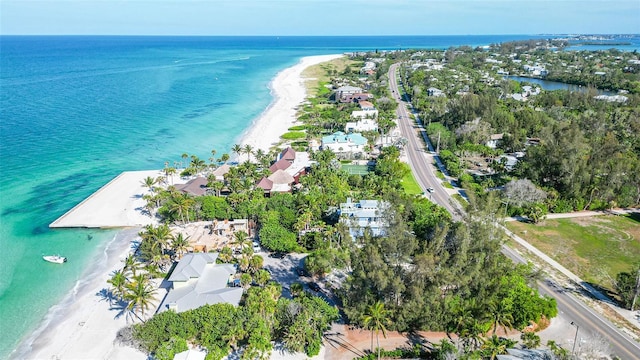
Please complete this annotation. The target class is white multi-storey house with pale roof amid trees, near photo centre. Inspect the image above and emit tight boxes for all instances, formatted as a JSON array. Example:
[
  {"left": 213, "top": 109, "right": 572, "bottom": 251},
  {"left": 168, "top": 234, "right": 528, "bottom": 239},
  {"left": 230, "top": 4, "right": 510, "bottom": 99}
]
[{"left": 340, "top": 198, "right": 386, "bottom": 240}]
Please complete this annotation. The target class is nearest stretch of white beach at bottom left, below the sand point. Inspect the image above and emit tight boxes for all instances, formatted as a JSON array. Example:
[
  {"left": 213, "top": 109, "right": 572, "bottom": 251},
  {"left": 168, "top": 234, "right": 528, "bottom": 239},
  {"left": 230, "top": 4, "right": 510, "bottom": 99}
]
[{"left": 9, "top": 228, "right": 144, "bottom": 359}]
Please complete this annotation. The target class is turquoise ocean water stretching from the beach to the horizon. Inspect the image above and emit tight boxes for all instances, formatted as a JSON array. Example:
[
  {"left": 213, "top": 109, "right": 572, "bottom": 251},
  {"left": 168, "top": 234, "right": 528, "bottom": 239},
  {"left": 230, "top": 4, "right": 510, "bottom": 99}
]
[{"left": 0, "top": 35, "right": 636, "bottom": 358}]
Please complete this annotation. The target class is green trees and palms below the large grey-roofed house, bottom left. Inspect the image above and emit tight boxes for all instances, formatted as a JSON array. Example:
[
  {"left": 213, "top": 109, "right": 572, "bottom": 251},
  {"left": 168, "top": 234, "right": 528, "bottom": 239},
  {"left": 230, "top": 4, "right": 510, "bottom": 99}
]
[{"left": 125, "top": 285, "right": 338, "bottom": 360}]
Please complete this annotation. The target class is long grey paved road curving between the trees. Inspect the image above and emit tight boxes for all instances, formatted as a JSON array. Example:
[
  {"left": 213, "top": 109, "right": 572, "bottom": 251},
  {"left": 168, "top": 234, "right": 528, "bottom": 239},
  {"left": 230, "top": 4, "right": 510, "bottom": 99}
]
[{"left": 388, "top": 63, "right": 640, "bottom": 360}]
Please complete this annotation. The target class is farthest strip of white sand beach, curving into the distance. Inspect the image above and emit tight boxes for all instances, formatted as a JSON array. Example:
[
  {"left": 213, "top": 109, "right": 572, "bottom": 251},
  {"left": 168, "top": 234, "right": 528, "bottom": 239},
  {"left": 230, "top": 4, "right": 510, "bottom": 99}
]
[{"left": 240, "top": 54, "right": 343, "bottom": 151}]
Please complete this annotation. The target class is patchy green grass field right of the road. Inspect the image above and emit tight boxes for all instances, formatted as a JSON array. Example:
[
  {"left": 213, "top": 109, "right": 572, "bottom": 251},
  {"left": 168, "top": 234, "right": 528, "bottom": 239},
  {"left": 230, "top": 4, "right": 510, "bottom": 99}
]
[{"left": 506, "top": 215, "right": 640, "bottom": 291}]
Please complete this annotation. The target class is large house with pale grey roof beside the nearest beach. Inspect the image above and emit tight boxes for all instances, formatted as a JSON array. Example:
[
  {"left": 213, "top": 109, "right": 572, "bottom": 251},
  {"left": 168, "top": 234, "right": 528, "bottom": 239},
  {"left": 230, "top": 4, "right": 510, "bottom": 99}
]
[{"left": 158, "top": 253, "right": 243, "bottom": 312}]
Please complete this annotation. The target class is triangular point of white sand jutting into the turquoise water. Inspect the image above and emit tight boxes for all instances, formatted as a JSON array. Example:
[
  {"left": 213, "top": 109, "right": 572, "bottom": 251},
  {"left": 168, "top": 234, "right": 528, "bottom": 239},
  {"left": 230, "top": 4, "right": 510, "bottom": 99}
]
[{"left": 49, "top": 170, "right": 163, "bottom": 228}]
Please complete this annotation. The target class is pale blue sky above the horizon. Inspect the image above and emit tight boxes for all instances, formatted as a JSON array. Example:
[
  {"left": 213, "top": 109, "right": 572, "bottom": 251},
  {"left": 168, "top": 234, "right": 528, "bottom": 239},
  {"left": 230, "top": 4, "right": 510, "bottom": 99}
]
[{"left": 0, "top": 0, "right": 640, "bottom": 36}]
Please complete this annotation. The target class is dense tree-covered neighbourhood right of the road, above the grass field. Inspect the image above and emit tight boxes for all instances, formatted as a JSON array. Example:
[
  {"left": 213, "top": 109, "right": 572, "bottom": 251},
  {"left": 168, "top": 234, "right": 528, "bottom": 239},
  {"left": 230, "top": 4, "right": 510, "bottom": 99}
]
[{"left": 401, "top": 42, "right": 640, "bottom": 215}]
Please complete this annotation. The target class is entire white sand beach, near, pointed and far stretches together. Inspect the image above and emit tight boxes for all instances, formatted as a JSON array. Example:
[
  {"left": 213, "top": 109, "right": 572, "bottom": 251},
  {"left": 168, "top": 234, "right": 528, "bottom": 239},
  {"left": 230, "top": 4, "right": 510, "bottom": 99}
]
[{"left": 12, "top": 55, "right": 342, "bottom": 360}]
